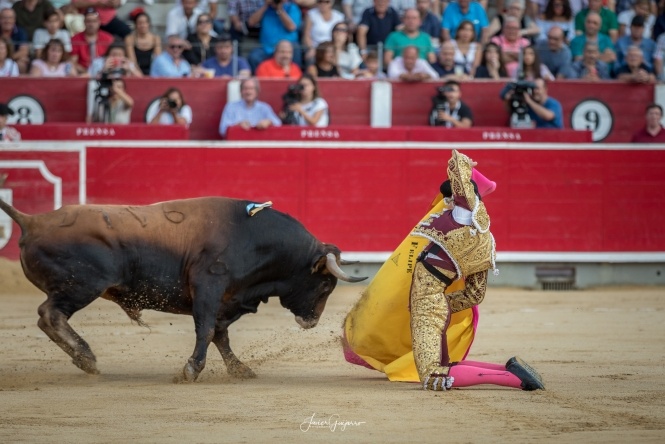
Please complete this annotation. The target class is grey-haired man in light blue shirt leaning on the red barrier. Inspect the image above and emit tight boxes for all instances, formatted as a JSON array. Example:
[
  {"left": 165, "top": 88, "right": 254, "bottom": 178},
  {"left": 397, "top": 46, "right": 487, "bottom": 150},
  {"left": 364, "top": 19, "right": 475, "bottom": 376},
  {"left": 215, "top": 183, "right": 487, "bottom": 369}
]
[{"left": 219, "top": 77, "right": 282, "bottom": 137}]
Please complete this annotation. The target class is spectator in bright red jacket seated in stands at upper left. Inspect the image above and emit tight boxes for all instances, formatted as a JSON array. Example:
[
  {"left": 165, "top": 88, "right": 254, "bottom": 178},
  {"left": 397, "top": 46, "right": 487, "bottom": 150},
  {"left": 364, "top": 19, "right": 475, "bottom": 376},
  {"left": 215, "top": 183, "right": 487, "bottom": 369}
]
[{"left": 72, "top": 8, "right": 113, "bottom": 74}]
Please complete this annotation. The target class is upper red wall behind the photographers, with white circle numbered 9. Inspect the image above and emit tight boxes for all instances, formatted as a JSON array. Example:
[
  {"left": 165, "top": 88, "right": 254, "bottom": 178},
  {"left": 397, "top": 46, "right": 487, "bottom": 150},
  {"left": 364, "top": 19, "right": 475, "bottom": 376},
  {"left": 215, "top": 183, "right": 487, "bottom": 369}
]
[{"left": 0, "top": 78, "right": 654, "bottom": 143}]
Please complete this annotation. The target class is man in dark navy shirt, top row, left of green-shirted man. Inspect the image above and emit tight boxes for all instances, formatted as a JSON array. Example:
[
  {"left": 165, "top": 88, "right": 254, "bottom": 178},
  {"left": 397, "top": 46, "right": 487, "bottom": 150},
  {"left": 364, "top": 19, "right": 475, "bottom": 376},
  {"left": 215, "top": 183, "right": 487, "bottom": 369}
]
[{"left": 357, "top": 0, "right": 401, "bottom": 56}]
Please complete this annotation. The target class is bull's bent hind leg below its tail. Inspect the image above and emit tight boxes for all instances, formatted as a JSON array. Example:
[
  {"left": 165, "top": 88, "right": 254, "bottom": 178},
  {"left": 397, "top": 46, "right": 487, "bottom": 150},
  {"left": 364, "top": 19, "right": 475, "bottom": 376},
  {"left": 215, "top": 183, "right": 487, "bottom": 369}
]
[{"left": 37, "top": 295, "right": 99, "bottom": 375}]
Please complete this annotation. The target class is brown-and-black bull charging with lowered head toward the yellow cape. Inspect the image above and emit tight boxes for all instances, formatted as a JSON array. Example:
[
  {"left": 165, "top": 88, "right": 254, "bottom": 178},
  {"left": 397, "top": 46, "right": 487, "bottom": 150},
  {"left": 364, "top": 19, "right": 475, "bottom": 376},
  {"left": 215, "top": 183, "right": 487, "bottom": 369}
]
[{"left": 0, "top": 197, "right": 365, "bottom": 381}]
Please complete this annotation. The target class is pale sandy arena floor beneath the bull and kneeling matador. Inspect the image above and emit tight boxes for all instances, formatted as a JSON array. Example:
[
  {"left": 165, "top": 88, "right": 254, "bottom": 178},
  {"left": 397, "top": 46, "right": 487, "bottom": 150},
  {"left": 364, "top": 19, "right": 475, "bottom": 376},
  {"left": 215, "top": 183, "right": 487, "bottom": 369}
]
[{"left": 0, "top": 259, "right": 665, "bottom": 444}]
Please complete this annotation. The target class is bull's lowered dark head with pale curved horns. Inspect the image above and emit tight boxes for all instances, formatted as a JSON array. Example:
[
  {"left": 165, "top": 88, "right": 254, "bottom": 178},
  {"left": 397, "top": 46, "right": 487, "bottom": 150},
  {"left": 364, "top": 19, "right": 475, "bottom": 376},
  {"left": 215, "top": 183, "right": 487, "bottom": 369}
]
[{"left": 282, "top": 245, "right": 367, "bottom": 328}]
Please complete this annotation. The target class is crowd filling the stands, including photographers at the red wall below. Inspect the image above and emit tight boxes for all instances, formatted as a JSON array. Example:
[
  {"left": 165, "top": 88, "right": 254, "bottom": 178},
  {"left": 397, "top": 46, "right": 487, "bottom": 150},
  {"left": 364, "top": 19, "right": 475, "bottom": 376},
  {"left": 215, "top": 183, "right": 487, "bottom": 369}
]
[{"left": 0, "top": 0, "right": 665, "bottom": 134}]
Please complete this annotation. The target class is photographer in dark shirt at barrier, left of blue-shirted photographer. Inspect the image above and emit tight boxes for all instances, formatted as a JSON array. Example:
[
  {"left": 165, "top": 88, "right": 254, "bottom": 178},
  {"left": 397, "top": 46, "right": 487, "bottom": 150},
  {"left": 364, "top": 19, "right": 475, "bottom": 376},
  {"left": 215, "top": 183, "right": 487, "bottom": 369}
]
[{"left": 429, "top": 80, "right": 473, "bottom": 128}]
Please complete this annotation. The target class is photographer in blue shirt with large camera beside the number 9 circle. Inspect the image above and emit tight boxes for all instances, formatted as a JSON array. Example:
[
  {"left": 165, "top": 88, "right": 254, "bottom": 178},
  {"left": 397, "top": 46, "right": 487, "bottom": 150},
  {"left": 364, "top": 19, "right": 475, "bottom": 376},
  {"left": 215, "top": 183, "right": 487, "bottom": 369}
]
[{"left": 501, "top": 79, "right": 563, "bottom": 128}]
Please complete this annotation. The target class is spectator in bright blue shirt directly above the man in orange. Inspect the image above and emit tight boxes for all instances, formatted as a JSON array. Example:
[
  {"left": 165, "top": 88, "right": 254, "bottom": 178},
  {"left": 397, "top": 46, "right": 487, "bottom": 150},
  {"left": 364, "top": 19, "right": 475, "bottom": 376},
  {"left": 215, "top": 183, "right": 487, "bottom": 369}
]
[{"left": 249, "top": 0, "right": 302, "bottom": 70}]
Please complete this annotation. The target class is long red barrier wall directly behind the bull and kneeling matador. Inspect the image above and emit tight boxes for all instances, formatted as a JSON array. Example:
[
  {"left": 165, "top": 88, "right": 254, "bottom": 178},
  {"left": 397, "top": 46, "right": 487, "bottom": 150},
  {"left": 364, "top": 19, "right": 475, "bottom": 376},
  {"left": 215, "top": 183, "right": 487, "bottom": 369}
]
[{"left": 0, "top": 142, "right": 665, "bottom": 257}]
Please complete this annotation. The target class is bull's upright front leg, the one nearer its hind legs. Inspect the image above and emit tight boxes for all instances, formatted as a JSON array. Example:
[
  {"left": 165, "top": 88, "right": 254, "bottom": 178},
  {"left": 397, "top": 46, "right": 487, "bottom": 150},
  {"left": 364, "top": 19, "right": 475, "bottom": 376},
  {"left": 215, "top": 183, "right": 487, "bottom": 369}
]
[{"left": 182, "top": 276, "right": 224, "bottom": 382}]
